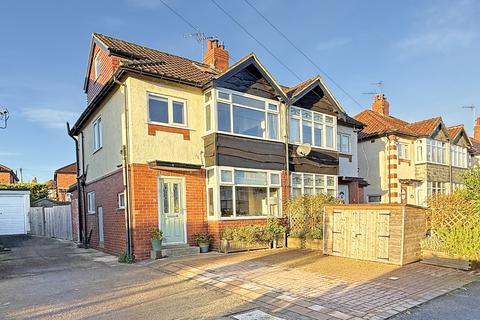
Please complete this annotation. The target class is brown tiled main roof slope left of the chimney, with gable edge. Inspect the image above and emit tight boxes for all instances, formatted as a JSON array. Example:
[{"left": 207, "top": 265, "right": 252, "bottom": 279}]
[{"left": 87, "top": 33, "right": 220, "bottom": 90}]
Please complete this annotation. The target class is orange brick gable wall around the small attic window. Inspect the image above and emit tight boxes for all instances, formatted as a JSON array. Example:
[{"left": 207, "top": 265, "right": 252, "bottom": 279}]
[{"left": 87, "top": 44, "right": 120, "bottom": 104}]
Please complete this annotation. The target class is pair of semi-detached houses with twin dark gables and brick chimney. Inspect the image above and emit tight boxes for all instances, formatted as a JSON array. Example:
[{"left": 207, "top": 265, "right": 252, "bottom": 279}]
[{"left": 70, "top": 33, "right": 366, "bottom": 259}]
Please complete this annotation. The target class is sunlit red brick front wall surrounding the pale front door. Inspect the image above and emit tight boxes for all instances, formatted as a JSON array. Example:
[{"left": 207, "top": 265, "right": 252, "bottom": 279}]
[{"left": 130, "top": 164, "right": 207, "bottom": 260}]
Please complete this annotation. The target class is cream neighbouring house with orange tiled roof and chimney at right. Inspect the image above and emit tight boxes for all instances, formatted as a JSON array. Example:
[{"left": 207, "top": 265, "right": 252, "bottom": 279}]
[{"left": 354, "top": 94, "right": 472, "bottom": 205}]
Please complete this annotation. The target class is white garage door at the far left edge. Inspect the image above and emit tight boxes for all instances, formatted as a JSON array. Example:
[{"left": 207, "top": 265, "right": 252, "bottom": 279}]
[{"left": 0, "top": 195, "right": 26, "bottom": 235}]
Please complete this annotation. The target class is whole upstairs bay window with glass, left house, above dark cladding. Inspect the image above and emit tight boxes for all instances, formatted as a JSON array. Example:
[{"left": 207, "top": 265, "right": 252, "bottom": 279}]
[{"left": 208, "top": 88, "right": 280, "bottom": 141}]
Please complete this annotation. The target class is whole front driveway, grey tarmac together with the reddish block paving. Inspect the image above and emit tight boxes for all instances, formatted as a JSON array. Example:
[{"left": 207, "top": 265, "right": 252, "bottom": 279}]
[{"left": 0, "top": 238, "right": 478, "bottom": 320}]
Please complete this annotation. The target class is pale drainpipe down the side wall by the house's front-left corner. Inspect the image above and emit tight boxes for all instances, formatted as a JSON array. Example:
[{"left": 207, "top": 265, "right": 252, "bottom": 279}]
[{"left": 113, "top": 77, "right": 133, "bottom": 256}]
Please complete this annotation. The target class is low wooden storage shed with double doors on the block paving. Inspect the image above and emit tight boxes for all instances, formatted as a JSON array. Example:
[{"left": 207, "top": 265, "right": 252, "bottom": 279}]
[{"left": 324, "top": 204, "right": 426, "bottom": 265}]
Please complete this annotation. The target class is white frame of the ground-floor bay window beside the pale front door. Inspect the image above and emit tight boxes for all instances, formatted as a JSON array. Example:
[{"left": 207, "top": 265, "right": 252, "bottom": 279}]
[{"left": 206, "top": 166, "right": 283, "bottom": 221}]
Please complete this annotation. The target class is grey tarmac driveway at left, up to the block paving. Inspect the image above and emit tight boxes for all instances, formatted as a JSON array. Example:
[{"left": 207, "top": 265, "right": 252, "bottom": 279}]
[{"left": 0, "top": 237, "right": 255, "bottom": 319}]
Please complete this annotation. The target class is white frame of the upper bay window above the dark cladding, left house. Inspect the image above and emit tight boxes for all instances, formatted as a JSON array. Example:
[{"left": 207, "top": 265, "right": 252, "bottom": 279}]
[{"left": 210, "top": 87, "right": 282, "bottom": 142}]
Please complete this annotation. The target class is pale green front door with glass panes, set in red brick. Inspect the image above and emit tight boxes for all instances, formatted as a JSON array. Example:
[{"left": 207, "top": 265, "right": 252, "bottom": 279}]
[{"left": 158, "top": 177, "right": 185, "bottom": 243}]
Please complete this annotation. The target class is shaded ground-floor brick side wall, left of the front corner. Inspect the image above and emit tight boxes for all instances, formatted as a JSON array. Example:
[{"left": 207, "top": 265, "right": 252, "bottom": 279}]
[{"left": 85, "top": 170, "right": 126, "bottom": 255}]
